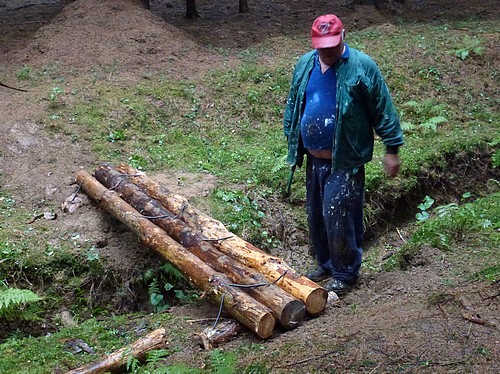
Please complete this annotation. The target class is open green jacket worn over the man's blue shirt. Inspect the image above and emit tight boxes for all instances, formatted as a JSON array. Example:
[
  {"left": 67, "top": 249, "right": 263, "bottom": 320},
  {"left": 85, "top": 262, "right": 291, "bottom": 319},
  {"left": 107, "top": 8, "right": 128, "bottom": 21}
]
[{"left": 283, "top": 46, "right": 403, "bottom": 170}]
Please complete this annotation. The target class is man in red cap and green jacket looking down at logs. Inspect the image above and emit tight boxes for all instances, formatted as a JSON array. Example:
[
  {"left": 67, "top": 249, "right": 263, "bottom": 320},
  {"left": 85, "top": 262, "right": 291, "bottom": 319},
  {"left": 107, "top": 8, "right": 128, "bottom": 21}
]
[{"left": 284, "top": 14, "right": 403, "bottom": 295}]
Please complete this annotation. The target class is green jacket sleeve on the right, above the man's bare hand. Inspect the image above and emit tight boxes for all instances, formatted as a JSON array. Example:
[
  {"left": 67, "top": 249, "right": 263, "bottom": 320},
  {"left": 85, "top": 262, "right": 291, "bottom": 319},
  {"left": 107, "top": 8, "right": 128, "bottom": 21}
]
[{"left": 367, "top": 59, "right": 404, "bottom": 150}]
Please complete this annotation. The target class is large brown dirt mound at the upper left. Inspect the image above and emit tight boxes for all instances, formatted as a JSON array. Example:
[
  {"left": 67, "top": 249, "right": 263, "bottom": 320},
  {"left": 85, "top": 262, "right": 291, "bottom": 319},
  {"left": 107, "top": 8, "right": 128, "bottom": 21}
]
[{"left": 13, "top": 0, "right": 217, "bottom": 75}]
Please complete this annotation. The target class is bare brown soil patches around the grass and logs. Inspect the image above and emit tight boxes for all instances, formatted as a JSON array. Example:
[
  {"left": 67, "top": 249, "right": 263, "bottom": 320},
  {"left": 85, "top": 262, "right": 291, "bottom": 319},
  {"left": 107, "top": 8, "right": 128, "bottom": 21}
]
[{"left": 0, "top": 0, "right": 500, "bottom": 373}]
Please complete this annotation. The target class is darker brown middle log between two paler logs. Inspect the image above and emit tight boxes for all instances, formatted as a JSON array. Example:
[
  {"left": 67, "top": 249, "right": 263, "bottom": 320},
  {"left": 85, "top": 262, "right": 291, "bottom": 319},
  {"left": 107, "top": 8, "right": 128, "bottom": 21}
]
[{"left": 95, "top": 164, "right": 306, "bottom": 329}]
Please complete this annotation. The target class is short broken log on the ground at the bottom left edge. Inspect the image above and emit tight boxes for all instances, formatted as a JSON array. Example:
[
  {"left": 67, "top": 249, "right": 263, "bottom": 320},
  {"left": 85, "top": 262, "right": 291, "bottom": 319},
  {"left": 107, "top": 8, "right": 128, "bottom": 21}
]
[{"left": 66, "top": 328, "right": 167, "bottom": 374}]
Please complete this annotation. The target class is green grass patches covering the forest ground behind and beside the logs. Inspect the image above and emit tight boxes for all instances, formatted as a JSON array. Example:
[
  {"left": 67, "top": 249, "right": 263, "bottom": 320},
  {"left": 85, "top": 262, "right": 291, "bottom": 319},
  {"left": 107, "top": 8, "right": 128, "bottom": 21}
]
[{"left": 0, "top": 15, "right": 500, "bottom": 373}]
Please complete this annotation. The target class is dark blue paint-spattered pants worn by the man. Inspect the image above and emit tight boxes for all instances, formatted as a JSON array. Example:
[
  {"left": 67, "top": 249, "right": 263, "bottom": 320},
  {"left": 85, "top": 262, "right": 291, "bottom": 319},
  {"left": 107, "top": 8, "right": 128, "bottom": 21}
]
[{"left": 306, "top": 155, "right": 365, "bottom": 282}]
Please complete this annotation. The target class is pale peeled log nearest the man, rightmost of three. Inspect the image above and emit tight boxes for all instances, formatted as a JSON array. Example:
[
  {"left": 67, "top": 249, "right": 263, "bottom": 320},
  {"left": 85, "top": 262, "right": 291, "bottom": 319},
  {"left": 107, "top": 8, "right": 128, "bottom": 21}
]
[{"left": 116, "top": 164, "right": 328, "bottom": 316}]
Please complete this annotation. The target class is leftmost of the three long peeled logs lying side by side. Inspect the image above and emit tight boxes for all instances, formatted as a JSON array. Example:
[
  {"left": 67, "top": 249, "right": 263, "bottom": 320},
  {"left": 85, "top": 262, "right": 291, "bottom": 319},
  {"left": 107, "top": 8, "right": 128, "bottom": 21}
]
[{"left": 76, "top": 169, "right": 276, "bottom": 339}]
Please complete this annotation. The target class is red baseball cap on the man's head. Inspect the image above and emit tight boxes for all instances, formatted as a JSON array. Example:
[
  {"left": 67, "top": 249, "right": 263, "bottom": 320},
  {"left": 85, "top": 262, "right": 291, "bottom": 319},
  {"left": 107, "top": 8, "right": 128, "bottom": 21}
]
[{"left": 311, "top": 14, "right": 344, "bottom": 49}]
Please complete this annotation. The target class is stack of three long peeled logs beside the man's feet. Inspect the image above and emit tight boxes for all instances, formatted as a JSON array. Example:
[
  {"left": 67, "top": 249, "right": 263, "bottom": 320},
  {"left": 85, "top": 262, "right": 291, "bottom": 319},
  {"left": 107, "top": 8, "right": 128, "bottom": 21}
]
[{"left": 76, "top": 163, "right": 328, "bottom": 339}]
